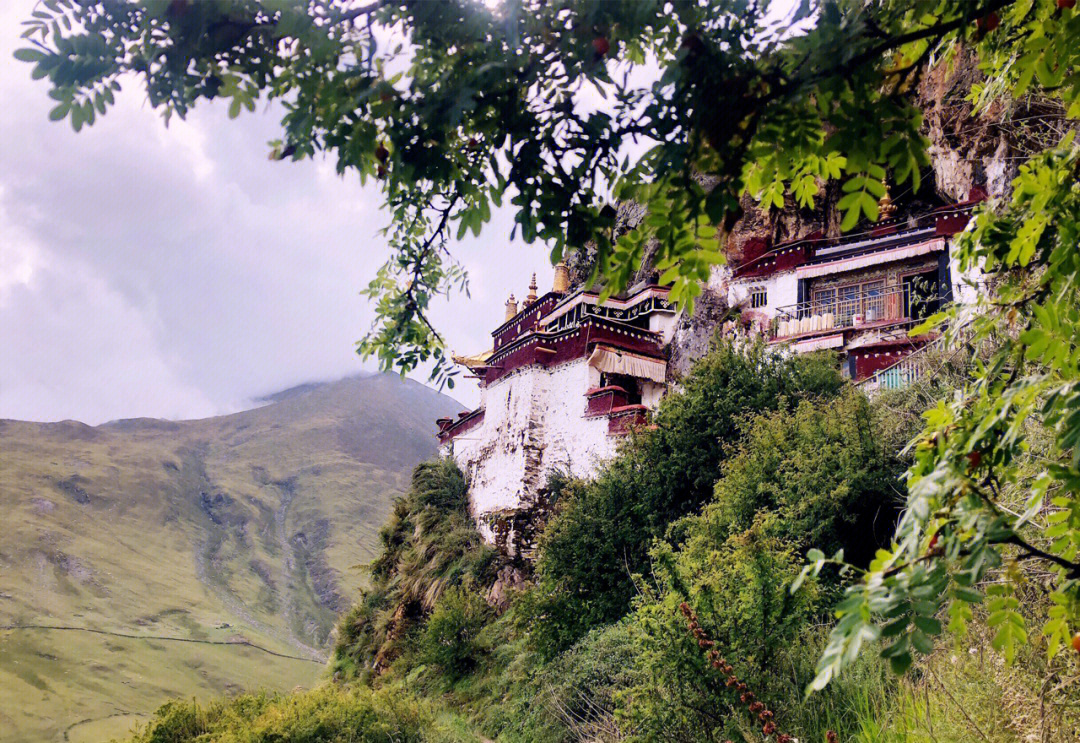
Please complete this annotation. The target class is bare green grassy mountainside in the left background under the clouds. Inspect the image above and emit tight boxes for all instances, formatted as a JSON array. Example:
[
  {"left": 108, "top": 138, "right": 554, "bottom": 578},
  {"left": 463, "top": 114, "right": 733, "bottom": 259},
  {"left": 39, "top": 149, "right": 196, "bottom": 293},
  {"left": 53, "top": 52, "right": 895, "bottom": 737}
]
[{"left": 0, "top": 376, "right": 459, "bottom": 742}]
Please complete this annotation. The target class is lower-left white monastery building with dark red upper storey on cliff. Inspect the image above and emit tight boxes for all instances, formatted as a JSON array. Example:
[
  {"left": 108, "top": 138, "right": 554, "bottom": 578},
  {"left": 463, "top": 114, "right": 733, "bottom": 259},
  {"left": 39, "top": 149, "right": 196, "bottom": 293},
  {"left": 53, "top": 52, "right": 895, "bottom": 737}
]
[{"left": 438, "top": 273, "right": 675, "bottom": 537}]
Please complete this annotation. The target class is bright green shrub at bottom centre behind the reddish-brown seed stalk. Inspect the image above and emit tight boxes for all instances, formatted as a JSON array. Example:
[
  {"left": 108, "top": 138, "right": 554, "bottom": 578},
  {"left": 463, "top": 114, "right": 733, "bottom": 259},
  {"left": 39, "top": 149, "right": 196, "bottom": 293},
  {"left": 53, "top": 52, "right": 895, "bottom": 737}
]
[{"left": 617, "top": 522, "right": 818, "bottom": 743}]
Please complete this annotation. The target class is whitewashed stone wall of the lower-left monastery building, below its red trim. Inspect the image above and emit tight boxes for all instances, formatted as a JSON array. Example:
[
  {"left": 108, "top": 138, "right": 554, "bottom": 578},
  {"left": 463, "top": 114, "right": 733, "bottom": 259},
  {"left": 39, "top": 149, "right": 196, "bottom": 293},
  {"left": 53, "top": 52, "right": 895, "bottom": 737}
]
[{"left": 444, "top": 359, "right": 618, "bottom": 536}]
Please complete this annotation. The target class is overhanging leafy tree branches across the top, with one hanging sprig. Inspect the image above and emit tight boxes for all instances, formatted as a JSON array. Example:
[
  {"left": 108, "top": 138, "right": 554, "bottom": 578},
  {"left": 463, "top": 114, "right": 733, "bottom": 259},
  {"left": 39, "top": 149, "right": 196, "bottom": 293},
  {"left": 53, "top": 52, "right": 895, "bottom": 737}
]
[{"left": 16, "top": 0, "right": 1062, "bottom": 381}]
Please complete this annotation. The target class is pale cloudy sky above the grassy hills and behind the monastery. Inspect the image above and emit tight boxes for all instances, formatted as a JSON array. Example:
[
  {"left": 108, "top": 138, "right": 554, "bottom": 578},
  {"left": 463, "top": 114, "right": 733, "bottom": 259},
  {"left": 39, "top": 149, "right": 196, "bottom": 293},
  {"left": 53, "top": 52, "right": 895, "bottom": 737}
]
[{"left": 0, "top": 0, "right": 552, "bottom": 423}]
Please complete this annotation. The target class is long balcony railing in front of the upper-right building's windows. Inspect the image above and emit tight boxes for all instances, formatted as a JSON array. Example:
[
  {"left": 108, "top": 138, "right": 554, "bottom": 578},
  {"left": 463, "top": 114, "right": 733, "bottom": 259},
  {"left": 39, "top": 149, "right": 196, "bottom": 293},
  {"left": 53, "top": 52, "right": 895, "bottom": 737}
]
[{"left": 770, "top": 283, "right": 942, "bottom": 340}]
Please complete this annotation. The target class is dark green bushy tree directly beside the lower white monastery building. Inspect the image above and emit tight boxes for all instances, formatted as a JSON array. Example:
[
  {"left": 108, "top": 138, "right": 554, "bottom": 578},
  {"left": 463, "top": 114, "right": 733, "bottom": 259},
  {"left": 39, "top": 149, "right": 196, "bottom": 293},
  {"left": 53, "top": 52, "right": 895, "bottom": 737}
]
[{"left": 529, "top": 341, "right": 843, "bottom": 653}]
